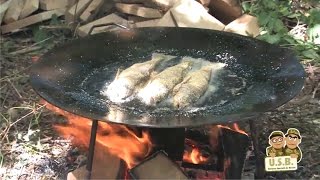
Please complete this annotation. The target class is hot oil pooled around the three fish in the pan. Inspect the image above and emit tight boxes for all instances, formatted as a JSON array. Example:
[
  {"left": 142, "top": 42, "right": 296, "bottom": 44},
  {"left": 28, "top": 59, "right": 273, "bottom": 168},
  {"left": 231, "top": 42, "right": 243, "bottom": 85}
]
[{"left": 81, "top": 52, "right": 250, "bottom": 112}]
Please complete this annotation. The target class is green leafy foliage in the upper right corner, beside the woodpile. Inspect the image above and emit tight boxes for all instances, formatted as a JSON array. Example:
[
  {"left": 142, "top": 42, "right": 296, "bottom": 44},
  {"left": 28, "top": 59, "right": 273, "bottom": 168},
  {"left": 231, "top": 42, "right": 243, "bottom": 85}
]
[{"left": 242, "top": 0, "right": 320, "bottom": 62}]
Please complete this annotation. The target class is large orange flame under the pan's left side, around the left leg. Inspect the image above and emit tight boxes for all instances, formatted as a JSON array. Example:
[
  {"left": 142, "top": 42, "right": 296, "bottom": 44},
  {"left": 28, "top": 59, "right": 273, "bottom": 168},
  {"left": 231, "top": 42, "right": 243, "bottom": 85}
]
[{"left": 46, "top": 103, "right": 152, "bottom": 168}]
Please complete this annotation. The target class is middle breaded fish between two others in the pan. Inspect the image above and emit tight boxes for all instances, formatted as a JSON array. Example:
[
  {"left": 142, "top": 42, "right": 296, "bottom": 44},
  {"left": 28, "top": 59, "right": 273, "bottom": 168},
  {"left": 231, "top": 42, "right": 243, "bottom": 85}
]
[{"left": 138, "top": 61, "right": 192, "bottom": 105}]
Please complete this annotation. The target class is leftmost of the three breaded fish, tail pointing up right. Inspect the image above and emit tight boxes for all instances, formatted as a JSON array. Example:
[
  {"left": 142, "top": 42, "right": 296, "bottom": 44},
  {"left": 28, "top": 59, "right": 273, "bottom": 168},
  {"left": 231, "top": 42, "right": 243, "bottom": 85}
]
[{"left": 103, "top": 54, "right": 172, "bottom": 102}]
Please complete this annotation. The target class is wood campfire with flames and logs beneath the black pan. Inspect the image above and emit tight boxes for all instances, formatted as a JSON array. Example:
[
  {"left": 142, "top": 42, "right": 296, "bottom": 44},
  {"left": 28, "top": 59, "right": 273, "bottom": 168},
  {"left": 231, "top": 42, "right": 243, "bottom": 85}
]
[{"left": 43, "top": 101, "right": 249, "bottom": 179}]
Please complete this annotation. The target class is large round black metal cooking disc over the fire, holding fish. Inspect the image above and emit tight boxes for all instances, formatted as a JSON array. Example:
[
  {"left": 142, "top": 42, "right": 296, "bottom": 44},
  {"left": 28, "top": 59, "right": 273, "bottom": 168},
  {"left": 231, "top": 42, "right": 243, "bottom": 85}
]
[{"left": 31, "top": 27, "right": 305, "bottom": 127}]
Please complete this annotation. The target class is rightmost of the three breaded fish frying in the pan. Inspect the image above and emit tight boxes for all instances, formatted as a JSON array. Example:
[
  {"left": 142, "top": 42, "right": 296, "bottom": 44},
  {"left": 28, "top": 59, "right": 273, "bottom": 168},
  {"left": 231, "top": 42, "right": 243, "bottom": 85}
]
[{"left": 173, "top": 65, "right": 212, "bottom": 109}]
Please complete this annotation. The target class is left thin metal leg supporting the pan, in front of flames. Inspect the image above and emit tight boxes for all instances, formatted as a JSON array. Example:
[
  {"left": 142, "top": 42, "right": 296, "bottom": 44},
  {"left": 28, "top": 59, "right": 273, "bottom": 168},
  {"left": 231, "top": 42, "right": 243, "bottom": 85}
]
[{"left": 87, "top": 120, "right": 98, "bottom": 179}]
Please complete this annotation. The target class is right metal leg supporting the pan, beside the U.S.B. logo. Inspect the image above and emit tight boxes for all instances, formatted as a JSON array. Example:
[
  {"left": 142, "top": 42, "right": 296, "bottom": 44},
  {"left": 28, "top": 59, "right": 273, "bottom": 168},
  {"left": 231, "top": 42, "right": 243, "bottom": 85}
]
[{"left": 249, "top": 119, "right": 265, "bottom": 179}]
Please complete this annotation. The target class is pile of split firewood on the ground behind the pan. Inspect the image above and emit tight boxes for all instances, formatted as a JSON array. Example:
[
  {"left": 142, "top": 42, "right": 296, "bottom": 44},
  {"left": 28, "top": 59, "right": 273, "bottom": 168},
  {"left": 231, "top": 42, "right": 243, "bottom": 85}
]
[{"left": 0, "top": 0, "right": 259, "bottom": 37}]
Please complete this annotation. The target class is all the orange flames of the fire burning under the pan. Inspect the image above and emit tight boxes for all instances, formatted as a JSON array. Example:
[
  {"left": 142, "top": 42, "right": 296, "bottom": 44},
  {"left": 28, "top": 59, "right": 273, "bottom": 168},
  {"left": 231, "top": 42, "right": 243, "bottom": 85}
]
[{"left": 45, "top": 99, "right": 247, "bottom": 179}]
